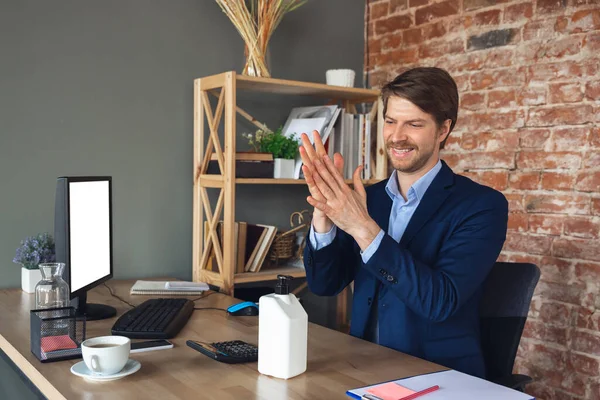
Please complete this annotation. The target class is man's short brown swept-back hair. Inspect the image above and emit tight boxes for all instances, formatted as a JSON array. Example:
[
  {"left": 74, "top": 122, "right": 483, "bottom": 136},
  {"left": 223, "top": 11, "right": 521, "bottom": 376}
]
[{"left": 381, "top": 67, "right": 458, "bottom": 149}]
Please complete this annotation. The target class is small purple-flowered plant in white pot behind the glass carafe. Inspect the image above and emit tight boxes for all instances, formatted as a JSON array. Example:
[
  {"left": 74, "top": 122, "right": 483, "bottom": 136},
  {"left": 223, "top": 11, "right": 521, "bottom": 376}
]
[{"left": 13, "top": 233, "right": 56, "bottom": 293}]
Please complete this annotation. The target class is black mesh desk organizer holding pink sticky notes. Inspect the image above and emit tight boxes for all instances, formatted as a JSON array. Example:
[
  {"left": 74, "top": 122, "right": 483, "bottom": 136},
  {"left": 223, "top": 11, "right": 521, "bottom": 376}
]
[{"left": 30, "top": 307, "right": 85, "bottom": 363}]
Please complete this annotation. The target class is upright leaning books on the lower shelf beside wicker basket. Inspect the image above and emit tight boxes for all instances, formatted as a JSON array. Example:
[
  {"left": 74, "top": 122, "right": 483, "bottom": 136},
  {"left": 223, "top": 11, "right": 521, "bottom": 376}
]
[{"left": 204, "top": 221, "right": 277, "bottom": 274}]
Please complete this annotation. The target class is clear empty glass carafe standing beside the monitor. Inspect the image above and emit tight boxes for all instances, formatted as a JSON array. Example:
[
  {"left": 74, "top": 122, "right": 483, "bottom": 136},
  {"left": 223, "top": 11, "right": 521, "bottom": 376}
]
[{"left": 35, "top": 263, "right": 70, "bottom": 309}]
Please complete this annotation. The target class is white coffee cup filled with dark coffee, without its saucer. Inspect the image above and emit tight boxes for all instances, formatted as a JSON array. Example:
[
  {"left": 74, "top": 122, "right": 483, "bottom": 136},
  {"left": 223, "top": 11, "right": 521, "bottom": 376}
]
[{"left": 81, "top": 336, "right": 131, "bottom": 375}]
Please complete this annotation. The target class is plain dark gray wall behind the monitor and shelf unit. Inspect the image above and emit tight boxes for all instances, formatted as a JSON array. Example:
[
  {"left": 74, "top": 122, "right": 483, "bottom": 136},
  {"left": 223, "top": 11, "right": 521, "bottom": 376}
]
[{"left": 0, "top": 0, "right": 364, "bottom": 324}]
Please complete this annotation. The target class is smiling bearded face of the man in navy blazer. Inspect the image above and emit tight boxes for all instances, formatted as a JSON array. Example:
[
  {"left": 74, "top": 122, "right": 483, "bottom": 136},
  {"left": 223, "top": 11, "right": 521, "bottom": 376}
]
[{"left": 383, "top": 96, "right": 451, "bottom": 175}]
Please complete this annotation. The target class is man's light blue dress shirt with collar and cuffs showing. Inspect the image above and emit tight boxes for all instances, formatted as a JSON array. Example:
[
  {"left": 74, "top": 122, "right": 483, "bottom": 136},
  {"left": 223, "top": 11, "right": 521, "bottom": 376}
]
[{"left": 309, "top": 160, "right": 442, "bottom": 343}]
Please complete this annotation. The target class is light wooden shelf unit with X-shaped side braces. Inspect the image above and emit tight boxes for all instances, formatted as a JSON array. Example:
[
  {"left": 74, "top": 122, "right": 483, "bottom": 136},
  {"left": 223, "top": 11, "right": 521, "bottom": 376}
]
[{"left": 193, "top": 71, "right": 387, "bottom": 295}]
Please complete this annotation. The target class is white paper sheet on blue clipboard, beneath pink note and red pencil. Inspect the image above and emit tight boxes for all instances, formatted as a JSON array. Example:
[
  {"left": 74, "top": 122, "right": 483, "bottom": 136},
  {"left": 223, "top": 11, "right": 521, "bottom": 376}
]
[{"left": 346, "top": 370, "right": 534, "bottom": 400}]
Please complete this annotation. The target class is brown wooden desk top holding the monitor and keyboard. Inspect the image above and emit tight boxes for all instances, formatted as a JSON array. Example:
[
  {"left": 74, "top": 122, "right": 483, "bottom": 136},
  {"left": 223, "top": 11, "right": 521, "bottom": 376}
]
[{"left": 0, "top": 280, "right": 445, "bottom": 400}]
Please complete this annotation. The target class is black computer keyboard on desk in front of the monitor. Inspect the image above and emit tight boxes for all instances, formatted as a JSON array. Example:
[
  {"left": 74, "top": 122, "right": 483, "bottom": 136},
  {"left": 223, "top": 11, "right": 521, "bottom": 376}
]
[{"left": 111, "top": 299, "right": 194, "bottom": 339}]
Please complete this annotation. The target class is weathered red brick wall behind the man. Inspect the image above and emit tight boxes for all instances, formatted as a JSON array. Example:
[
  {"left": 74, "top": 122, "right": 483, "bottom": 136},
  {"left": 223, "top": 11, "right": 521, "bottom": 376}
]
[{"left": 365, "top": 0, "right": 600, "bottom": 400}]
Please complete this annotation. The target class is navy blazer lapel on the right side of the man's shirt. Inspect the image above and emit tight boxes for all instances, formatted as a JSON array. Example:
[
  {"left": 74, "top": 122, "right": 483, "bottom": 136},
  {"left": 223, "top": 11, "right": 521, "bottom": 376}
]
[{"left": 400, "top": 161, "right": 454, "bottom": 247}]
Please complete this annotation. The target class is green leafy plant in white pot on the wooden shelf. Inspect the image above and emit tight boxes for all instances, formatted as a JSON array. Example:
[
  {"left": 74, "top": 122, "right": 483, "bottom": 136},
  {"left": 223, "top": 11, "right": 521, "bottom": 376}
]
[{"left": 243, "top": 127, "right": 300, "bottom": 179}]
